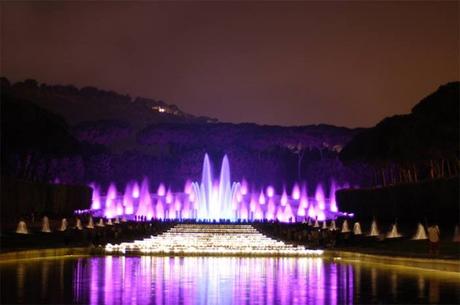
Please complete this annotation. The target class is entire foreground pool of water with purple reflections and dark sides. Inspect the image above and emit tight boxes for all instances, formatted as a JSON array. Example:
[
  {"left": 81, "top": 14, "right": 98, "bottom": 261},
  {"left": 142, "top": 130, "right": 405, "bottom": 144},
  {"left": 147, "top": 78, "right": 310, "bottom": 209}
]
[{"left": 0, "top": 256, "right": 460, "bottom": 305}]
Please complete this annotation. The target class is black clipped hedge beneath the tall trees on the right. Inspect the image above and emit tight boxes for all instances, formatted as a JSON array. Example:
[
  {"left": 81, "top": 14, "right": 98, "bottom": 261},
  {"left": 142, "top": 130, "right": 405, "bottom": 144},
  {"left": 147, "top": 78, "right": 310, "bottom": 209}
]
[{"left": 336, "top": 177, "right": 460, "bottom": 223}]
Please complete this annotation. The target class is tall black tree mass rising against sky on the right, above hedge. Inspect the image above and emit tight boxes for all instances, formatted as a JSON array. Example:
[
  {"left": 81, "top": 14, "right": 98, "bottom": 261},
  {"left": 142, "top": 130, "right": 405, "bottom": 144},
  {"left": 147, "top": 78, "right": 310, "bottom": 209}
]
[{"left": 340, "top": 82, "right": 460, "bottom": 186}]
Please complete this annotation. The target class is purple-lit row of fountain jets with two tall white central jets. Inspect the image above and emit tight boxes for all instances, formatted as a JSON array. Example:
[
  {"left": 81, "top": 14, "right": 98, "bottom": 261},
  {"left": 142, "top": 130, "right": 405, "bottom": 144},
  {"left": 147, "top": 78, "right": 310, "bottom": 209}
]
[{"left": 87, "top": 154, "right": 352, "bottom": 222}]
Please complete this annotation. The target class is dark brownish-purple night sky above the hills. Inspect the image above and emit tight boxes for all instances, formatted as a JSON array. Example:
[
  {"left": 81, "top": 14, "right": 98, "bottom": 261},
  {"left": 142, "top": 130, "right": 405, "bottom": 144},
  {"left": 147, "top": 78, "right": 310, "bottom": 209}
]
[{"left": 0, "top": 1, "right": 460, "bottom": 127}]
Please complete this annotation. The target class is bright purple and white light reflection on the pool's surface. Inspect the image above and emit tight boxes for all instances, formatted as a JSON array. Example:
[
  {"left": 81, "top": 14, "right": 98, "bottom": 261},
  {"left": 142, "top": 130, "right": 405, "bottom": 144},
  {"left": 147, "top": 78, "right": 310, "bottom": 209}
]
[{"left": 79, "top": 256, "right": 355, "bottom": 305}]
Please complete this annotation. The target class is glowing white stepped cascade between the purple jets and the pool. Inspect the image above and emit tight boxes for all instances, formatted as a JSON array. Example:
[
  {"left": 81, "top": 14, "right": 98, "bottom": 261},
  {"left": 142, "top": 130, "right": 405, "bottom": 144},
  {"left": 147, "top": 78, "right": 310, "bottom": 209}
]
[{"left": 105, "top": 224, "right": 323, "bottom": 256}]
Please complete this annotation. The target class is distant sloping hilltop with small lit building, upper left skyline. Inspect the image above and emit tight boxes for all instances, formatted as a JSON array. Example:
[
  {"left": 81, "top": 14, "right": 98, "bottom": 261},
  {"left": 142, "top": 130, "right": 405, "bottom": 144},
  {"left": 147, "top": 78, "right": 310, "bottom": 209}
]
[{"left": 2, "top": 78, "right": 216, "bottom": 127}]
